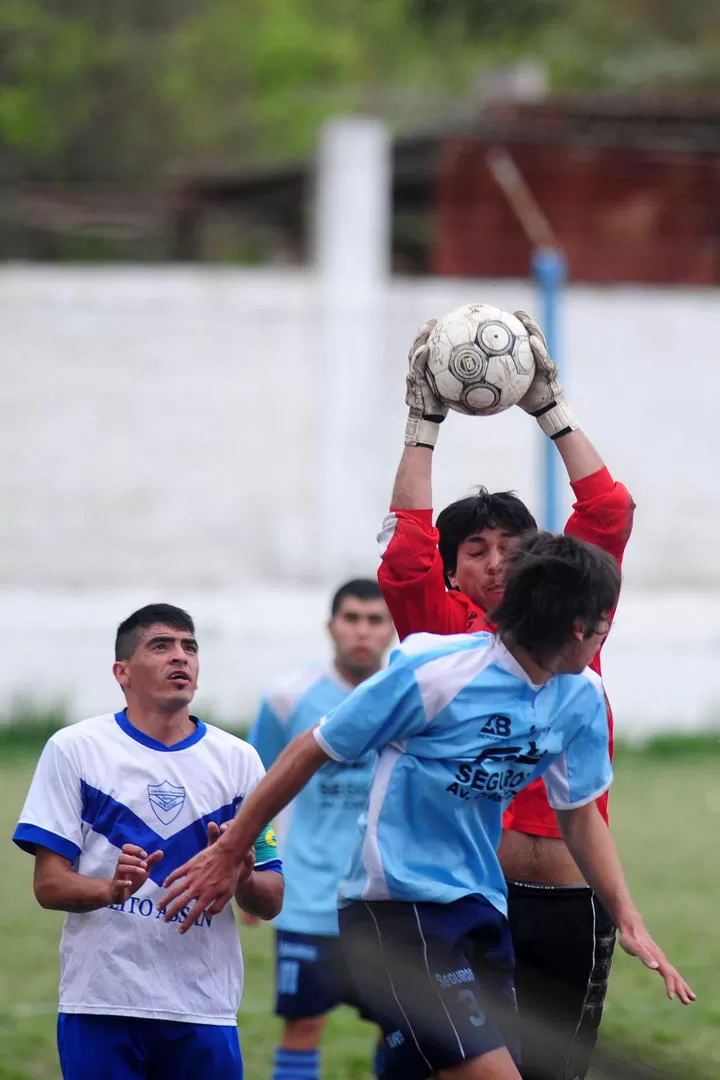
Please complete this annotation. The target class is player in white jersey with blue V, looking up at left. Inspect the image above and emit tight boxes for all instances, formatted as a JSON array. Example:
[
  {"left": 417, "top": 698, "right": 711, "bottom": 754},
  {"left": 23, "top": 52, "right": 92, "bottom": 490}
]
[{"left": 14, "top": 604, "right": 283, "bottom": 1080}]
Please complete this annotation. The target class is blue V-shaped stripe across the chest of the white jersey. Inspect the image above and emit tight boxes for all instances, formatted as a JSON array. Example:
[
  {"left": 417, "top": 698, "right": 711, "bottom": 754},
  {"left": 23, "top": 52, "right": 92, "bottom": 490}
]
[{"left": 80, "top": 780, "right": 243, "bottom": 885}]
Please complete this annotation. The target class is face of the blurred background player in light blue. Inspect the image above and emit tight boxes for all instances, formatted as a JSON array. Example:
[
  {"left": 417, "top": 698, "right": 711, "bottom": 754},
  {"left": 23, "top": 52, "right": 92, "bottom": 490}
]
[{"left": 328, "top": 596, "right": 395, "bottom": 683}]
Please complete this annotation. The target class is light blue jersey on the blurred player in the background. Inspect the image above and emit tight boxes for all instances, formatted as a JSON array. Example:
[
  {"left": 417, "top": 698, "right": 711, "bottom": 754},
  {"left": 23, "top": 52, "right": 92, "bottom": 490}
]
[{"left": 248, "top": 663, "right": 377, "bottom": 934}]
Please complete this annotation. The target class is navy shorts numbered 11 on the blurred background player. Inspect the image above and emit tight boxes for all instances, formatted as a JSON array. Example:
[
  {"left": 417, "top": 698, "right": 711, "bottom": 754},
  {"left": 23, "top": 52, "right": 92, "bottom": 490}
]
[{"left": 275, "top": 930, "right": 369, "bottom": 1020}]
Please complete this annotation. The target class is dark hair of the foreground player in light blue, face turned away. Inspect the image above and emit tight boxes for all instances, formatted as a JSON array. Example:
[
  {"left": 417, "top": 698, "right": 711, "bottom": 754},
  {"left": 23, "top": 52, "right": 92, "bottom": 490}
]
[{"left": 491, "top": 531, "right": 621, "bottom": 664}]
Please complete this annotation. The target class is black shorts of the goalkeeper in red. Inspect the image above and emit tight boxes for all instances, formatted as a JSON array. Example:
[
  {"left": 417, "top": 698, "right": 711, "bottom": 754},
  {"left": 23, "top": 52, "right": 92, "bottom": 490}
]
[{"left": 507, "top": 881, "right": 615, "bottom": 1080}]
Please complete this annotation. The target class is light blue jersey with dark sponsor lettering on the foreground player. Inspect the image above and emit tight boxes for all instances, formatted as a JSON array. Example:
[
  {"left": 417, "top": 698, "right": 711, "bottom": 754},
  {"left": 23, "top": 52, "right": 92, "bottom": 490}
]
[{"left": 313, "top": 633, "right": 612, "bottom": 915}]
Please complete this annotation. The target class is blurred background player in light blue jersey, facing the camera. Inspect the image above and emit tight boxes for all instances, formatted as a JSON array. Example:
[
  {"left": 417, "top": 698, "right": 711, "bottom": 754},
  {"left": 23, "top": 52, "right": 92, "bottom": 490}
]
[{"left": 248, "top": 578, "right": 394, "bottom": 1080}]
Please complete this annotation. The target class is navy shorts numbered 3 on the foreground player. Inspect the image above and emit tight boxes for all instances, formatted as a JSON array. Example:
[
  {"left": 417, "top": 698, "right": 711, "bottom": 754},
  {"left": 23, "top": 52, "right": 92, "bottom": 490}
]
[{"left": 340, "top": 896, "right": 518, "bottom": 1080}]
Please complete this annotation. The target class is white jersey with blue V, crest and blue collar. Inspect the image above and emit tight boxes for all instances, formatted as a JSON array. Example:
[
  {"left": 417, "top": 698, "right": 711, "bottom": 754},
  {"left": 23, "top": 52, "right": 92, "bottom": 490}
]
[{"left": 13, "top": 713, "right": 282, "bottom": 1025}]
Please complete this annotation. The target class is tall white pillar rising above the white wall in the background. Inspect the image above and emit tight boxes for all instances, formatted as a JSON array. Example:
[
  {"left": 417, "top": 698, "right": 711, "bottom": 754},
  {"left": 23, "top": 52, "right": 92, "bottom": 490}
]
[{"left": 315, "top": 117, "right": 392, "bottom": 581}]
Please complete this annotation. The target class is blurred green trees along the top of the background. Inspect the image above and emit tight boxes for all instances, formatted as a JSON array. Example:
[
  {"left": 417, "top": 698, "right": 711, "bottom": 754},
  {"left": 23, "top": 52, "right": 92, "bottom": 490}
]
[{"left": 0, "top": 0, "right": 720, "bottom": 185}]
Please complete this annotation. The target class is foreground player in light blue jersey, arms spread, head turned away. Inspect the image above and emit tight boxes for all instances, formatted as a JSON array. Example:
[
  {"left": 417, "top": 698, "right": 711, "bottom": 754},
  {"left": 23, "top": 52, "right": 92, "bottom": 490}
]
[{"left": 162, "top": 534, "right": 694, "bottom": 1080}]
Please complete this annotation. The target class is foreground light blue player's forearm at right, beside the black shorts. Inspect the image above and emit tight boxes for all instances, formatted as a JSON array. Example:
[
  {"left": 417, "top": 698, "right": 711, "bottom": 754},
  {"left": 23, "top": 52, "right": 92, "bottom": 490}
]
[{"left": 557, "top": 802, "right": 638, "bottom": 930}]
